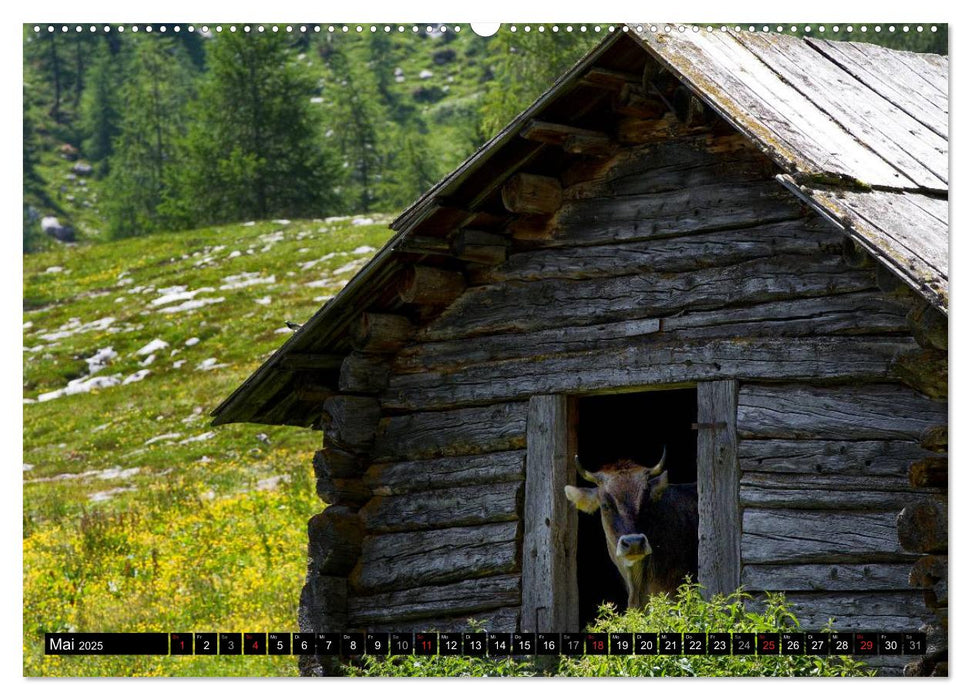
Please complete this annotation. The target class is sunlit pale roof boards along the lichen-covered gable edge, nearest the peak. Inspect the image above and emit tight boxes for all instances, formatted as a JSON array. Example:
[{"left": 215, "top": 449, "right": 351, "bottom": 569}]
[{"left": 635, "top": 31, "right": 917, "bottom": 188}]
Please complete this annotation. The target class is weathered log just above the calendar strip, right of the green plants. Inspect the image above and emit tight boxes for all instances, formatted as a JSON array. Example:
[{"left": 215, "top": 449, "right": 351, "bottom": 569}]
[{"left": 768, "top": 591, "right": 931, "bottom": 636}]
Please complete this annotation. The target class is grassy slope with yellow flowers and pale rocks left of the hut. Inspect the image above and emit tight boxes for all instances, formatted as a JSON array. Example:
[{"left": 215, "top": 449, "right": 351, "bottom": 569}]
[{"left": 23, "top": 219, "right": 390, "bottom": 676}]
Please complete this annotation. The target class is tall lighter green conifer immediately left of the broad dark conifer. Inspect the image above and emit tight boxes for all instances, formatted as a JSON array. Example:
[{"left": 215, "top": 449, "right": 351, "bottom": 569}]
[{"left": 104, "top": 37, "right": 192, "bottom": 237}]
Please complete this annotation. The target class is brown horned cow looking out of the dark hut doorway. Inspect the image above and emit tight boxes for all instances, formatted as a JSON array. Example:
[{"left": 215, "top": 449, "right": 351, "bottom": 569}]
[{"left": 564, "top": 447, "right": 698, "bottom": 608}]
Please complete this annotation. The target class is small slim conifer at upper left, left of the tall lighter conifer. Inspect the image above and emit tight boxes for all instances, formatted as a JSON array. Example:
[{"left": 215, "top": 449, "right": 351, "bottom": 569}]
[{"left": 81, "top": 42, "right": 121, "bottom": 171}]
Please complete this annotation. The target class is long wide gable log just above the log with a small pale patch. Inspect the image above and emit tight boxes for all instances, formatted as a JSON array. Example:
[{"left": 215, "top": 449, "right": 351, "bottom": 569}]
[{"left": 418, "top": 254, "right": 875, "bottom": 341}]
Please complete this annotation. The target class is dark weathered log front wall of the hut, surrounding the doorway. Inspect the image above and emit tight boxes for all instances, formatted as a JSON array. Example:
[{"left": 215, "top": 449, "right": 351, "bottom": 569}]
[{"left": 311, "top": 133, "right": 947, "bottom": 672}]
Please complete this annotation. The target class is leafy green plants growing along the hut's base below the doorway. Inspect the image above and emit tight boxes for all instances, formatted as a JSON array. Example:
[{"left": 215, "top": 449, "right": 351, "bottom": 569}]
[{"left": 345, "top": 583, "right": 873, "bottom": 677}]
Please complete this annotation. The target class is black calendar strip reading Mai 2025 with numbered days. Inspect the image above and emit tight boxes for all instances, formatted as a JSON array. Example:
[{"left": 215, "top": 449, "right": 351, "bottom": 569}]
[{"left": 44, "top": 632, "right": 927, "bottom": 658}]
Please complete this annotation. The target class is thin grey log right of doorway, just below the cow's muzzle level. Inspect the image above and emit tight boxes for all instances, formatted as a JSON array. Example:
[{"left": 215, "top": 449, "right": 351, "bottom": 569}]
[{"left": 742, "top": 563, "right": 914, "bottom": 591}]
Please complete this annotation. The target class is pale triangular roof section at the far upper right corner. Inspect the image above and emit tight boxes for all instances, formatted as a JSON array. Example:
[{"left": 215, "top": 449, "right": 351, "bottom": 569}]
[{"left": 806, "top": 39, "right": 948, "bottom": 138}]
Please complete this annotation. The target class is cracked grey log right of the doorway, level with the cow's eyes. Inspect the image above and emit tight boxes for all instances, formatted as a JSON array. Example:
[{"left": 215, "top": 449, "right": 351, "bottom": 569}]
[{"left": 738, "top": 472, "right": 933, "bottom": 511}]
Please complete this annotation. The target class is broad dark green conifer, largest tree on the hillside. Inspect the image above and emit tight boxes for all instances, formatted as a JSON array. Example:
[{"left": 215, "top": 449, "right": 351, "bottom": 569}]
[{"left": 171, "top": 33, "right": 336, "bottom": 225}]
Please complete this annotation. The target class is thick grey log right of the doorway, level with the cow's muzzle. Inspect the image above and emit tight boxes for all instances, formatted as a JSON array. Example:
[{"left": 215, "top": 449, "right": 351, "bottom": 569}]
[{"left": 742, "top": 508, "right": 913, "bottom": 565}]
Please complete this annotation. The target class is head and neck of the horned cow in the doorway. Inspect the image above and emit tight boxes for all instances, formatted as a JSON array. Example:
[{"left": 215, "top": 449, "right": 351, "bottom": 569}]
[{"left": 564, "top": 448, "right": 668, "bottom": 605}]
